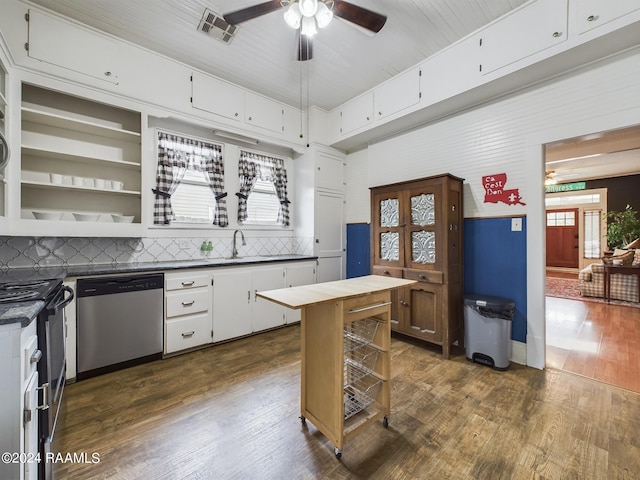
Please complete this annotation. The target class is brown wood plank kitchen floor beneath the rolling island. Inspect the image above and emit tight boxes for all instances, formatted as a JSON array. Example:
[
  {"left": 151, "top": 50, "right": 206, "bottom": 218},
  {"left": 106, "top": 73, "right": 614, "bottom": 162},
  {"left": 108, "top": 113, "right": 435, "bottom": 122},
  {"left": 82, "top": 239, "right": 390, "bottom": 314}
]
[{"left": 53, "top": 326, "right": 640, "bottom": 480}]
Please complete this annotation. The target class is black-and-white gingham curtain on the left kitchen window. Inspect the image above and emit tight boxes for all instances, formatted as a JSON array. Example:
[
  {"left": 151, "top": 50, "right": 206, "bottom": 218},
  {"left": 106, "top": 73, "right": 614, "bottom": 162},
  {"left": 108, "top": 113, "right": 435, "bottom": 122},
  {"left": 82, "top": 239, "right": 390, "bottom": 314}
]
[{"left": 153, "top": 132, "right": 229, "bottom": 227}]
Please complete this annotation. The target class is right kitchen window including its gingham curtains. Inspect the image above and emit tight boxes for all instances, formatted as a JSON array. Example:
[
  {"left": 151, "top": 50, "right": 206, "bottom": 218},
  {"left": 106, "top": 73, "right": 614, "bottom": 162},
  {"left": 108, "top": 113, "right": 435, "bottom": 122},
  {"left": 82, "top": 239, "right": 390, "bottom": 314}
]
[{"left": 236, "top": 151, "right": 289, "bottom": 227}]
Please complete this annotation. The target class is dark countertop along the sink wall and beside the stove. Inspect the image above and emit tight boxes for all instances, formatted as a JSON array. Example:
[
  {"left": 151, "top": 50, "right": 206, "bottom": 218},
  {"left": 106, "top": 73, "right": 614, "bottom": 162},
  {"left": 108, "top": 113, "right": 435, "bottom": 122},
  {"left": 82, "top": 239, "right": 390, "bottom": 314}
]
[{"left": 0, "top": 255, "right": 318, "bottom": 327}]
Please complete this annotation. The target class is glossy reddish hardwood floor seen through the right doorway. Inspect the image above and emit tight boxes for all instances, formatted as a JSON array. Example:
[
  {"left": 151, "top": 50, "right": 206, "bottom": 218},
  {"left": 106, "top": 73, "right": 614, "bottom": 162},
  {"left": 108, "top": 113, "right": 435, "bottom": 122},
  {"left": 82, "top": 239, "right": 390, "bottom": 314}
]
[{"left": 546, "top": 297, "right": 640, "bottom": 393}]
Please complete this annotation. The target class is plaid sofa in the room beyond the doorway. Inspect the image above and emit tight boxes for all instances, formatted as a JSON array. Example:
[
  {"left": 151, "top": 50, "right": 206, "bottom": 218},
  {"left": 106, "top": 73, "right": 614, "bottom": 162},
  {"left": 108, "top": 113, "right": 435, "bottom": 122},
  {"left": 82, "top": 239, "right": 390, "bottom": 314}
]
[{"left": 578, "top": 249, "right": 640, "bottom": 302}]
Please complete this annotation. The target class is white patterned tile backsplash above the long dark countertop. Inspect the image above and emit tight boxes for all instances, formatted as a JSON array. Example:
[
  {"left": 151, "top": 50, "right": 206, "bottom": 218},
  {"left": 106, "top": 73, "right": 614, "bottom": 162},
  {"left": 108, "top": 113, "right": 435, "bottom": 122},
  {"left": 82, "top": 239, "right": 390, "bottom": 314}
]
[{"left": 0, "top": 233, "right": 313, "bottom": 270}]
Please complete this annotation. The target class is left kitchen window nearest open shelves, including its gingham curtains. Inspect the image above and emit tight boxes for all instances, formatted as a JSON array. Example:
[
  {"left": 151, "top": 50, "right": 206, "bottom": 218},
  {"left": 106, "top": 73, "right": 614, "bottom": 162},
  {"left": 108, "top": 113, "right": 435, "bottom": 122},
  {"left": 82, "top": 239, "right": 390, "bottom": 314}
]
[{"left": 153, "top": 131, "right": 229, "bottom": 227}]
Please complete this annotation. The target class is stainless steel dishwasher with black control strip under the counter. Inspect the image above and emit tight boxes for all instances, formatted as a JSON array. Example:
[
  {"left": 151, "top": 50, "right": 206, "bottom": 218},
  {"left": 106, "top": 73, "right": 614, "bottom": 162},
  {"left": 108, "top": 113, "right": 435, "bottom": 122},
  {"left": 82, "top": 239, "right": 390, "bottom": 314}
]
[{"left": 76, "top": 273, "right": 164, "bottom": 380}]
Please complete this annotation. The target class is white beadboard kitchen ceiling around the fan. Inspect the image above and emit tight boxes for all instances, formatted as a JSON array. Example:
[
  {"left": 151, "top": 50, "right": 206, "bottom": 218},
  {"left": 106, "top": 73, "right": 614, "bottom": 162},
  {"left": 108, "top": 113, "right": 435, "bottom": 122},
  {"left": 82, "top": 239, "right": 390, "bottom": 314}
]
[{"left": 25, "top": 0, "right": 526, "bottom": 110}]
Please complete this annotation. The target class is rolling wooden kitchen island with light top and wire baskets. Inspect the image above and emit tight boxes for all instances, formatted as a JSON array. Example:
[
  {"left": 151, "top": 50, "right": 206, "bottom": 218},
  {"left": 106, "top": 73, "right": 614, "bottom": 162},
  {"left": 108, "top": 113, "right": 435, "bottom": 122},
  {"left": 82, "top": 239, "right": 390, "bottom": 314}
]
[{"left": 257, "top": 275, "right": 416, "bottom": 458}]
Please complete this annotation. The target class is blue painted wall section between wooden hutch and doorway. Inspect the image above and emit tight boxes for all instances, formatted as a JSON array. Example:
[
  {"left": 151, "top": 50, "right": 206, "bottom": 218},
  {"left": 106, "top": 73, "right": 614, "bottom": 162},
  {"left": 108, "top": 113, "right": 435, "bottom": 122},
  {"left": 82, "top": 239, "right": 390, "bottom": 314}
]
[{"left": 464, "top": 218, "right": 527, "bottom": 342}]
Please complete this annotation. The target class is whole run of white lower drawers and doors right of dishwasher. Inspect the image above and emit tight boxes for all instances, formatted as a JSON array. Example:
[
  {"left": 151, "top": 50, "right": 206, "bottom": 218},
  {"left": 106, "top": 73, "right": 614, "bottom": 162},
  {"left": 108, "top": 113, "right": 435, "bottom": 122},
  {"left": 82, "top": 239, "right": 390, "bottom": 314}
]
[{"left": 164, "top": 261, "right": 316, "bottom": 355}]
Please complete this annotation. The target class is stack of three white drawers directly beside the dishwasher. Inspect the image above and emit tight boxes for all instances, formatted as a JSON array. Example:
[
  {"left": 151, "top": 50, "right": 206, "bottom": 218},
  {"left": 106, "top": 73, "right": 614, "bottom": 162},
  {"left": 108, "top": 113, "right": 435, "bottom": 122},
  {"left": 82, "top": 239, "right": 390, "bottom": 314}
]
[{"left": 164, "top": 270, "right": 213, "bottom": 354}]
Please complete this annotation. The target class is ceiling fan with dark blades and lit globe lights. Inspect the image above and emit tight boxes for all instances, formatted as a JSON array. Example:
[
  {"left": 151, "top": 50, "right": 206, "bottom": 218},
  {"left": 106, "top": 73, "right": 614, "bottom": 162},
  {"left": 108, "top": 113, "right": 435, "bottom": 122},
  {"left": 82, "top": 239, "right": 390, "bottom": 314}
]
[{"left": 224, "top": 0, "right": 387, "bottom": 61}]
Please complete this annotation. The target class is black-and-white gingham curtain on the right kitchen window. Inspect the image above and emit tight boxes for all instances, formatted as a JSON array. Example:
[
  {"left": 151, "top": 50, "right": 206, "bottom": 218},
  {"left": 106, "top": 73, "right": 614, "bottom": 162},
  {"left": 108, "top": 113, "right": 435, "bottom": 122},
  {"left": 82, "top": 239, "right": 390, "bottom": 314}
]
[{"left": 236, "top": 151, "right": 290, "bottom": 227}]
